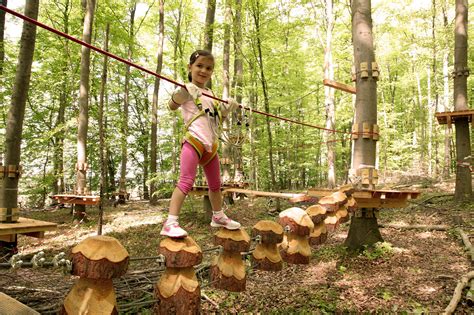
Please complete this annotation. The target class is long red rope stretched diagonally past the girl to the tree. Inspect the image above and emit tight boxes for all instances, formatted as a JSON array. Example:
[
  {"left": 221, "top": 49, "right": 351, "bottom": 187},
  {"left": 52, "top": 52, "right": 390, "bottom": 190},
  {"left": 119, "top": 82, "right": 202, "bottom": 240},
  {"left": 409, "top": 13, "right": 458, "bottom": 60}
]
[{"left": 0, "top": 5, "right": 378, "bottom": 141}]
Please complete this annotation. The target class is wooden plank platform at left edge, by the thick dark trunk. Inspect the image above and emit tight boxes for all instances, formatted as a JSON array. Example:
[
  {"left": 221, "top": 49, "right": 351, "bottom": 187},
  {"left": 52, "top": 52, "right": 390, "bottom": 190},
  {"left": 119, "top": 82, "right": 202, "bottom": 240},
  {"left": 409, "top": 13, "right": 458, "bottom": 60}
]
[{"left": 0, "top": 217, "right": 57, "bottom": 242}]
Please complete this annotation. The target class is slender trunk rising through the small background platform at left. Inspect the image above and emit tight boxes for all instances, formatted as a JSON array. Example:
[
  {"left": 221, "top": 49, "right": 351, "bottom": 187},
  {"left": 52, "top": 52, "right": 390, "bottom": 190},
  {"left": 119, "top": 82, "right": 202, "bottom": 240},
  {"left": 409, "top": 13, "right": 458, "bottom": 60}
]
[{"left": 74, "top": 0, "right": 95, "bottom": 221}]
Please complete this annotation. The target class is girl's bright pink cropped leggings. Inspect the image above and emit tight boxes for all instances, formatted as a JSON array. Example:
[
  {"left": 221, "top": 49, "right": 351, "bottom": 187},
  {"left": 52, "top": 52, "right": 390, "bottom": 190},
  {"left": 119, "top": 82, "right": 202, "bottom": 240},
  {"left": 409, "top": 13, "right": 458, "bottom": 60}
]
[{"left": 177, "top": 142, "right": 221, "bottom": 195}]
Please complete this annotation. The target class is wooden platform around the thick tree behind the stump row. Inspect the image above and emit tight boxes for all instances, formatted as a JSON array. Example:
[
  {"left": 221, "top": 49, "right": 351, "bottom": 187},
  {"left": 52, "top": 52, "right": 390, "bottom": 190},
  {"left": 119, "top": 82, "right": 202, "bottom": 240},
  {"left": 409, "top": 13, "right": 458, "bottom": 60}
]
[{"left": 308, "top": 188, "right": 421, "bottom": 208}]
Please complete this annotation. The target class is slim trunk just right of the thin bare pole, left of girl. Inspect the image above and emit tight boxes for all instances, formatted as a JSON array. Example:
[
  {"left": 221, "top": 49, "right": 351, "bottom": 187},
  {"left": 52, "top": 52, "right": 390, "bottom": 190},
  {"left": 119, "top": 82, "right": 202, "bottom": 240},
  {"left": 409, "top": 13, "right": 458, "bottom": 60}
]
[{"left": 119, "top": 2, "right": 137, "bottom": 202}]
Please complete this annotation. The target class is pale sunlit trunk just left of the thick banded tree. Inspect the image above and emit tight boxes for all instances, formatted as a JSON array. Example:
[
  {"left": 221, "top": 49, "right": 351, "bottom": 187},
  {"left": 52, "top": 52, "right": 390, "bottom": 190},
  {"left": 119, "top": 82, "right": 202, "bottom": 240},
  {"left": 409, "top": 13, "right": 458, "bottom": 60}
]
[{"left": 324, "top": 0, "right": 336, "bottom": 188}]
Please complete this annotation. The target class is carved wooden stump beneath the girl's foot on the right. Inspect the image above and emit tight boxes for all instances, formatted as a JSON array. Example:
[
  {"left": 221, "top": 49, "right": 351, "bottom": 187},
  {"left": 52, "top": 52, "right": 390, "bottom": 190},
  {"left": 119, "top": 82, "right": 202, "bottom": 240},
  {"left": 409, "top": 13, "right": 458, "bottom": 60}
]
[{"left": 211, "top": 228, "right": 250, "bottom": 292}]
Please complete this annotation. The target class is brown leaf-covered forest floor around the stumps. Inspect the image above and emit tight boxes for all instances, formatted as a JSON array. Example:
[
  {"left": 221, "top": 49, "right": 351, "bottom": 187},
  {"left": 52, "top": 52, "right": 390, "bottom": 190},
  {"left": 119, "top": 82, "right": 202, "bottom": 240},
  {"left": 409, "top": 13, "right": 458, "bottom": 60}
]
[{"left": 0, "top": 181, "right": 474, "bottom": 314}]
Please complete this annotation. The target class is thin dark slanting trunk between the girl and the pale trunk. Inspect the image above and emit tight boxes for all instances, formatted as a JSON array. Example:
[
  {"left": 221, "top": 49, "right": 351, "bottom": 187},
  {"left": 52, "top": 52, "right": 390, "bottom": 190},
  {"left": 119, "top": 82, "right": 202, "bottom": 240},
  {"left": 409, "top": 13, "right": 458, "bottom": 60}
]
[{"left": 252, "top": 0, "right": 280, "bottom": 211}]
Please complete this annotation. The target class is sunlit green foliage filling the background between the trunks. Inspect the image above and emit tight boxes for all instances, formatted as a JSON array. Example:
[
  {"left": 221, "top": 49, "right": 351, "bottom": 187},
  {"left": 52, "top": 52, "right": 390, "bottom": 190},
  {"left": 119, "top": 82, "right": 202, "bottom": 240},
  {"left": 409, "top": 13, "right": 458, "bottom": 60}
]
[{"left": 0, "top": 0, "right": 474, "bottom": 204}]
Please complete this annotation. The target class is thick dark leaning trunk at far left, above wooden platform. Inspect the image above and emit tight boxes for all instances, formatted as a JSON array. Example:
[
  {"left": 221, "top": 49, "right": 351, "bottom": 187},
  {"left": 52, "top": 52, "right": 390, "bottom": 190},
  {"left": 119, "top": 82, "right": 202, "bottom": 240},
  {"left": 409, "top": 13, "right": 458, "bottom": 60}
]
[{"left": 0, "top": 0, "right": 39, "bottom": 222}]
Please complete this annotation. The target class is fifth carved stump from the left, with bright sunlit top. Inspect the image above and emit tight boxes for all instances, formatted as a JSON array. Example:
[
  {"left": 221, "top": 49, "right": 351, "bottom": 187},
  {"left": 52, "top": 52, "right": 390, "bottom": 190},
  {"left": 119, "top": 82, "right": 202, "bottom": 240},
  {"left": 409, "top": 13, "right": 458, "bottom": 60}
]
[{"left": 279, "top": 207, "right": 314, "bottom": 264}]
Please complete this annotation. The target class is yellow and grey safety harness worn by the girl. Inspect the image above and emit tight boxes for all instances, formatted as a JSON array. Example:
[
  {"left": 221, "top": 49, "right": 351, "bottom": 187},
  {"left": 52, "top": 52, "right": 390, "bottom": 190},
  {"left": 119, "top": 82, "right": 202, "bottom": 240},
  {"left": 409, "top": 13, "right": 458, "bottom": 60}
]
[{"left": 183, "top": 93, "right": 222, "bottom": 166}]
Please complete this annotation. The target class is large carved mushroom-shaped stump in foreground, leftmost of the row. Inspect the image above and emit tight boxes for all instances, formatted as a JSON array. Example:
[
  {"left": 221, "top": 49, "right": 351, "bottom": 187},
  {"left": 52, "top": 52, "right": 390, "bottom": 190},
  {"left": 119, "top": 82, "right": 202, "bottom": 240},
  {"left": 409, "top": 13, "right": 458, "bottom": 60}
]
[{"left": 61, "top": 235, "right": 129, "bottom": 314}]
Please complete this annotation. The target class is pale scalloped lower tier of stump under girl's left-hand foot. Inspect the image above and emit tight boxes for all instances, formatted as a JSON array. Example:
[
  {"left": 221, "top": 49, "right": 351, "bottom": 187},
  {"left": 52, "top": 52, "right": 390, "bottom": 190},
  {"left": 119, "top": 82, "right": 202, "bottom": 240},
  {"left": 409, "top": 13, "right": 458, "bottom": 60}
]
[{"left": 158, "top": 267, "right": 199, "bottom": 299}]
